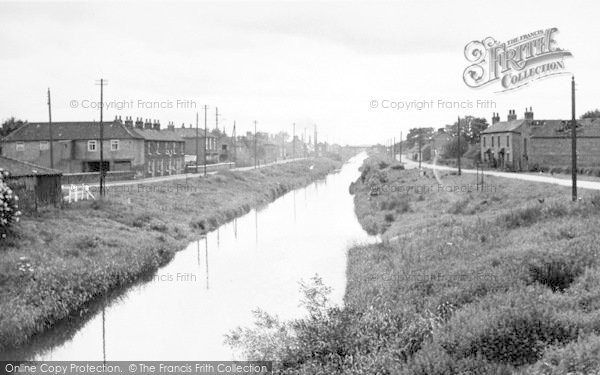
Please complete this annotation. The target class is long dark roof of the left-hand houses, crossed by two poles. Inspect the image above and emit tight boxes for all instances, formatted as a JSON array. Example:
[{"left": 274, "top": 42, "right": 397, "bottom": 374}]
[{"left": 4, "top": 121, "right": 141, "bottom": 142}]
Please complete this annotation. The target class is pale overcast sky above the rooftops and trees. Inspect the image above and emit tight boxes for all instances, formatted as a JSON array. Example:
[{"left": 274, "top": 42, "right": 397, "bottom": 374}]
[{"left": 0, "top": 0, "right": 600, "bottom": 144}]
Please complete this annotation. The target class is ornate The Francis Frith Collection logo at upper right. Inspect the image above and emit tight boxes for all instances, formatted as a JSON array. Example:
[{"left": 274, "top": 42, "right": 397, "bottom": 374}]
[{"left": 463, "top": 28, "right": 572, "bottom": 91}]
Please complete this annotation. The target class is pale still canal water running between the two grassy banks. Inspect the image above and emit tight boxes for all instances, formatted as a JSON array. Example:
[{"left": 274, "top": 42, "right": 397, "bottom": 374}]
[{"left": 8, "top": 154, "right": 374, "bottom": 361}]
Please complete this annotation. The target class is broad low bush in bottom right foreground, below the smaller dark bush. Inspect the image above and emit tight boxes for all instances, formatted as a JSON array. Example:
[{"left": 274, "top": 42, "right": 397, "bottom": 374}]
[{"left": 437, "top": 292, "right": 577, "bottom": 366}]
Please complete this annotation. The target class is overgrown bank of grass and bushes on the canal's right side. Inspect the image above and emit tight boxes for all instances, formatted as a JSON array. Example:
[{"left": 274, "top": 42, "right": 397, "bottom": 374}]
[{"left": 224, "top": 153, "right": 600, "bottom": 375}]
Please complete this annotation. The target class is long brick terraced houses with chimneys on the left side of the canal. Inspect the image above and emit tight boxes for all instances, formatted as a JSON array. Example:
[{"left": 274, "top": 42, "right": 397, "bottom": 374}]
[{"left": 2, "top": 118, "right": 184, "bottom": 178}]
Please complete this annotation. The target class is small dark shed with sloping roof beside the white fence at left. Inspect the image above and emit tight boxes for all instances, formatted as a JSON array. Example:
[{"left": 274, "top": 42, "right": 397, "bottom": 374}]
[{"left": 0, "top": 156, "right": 62, "bottom": 212}]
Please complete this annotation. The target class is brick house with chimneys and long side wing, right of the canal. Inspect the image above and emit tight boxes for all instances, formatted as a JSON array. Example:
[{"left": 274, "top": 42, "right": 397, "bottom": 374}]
[{"left": 481, "top": 108, "right": 600, "bottom": 171}]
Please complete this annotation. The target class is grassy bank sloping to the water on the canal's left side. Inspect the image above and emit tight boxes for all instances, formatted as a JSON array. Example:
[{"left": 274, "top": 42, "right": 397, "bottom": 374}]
[{"left": 0, "top": 158, "right": 340, "bottom": 352}]
